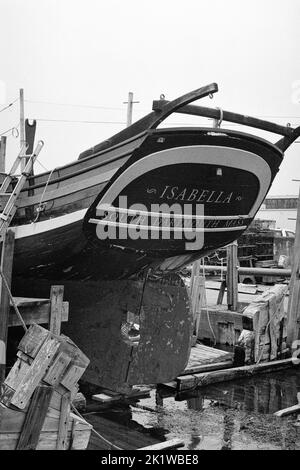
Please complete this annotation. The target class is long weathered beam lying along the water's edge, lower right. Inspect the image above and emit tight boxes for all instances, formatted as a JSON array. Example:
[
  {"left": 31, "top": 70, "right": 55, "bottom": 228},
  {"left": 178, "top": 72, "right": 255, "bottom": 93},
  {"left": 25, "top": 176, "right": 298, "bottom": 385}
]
[{"left": 177, "top": 358, "right": 297, "bottom": 391}]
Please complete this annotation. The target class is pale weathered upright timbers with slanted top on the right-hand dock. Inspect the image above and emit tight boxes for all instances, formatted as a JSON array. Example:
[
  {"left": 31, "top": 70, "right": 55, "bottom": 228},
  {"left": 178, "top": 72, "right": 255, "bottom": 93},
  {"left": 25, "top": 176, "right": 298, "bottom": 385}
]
[{"left": 243, "top": 284, "right": 288, "bottom": 362}]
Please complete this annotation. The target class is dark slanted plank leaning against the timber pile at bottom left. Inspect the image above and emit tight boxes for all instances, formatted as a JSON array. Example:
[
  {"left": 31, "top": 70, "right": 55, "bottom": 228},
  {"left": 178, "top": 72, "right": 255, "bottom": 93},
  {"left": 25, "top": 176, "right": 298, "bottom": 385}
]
[{"left": 17, "top": 385, "right": 52, "bottom": 450}]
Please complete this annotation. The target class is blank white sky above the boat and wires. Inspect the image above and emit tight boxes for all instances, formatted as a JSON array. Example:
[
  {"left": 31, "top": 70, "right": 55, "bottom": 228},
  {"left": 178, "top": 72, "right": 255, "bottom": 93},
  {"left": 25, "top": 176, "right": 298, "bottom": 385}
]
[{"left": 0, "top": 0, "right": 300, "bottom": 194}]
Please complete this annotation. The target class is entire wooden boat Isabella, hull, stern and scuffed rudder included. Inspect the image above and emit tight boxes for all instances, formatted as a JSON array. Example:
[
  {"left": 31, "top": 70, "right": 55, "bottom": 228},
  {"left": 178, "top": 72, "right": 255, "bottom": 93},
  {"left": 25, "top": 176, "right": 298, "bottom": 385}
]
[{"left": 8, "top": 84, "right": 299, "bottom": 390}]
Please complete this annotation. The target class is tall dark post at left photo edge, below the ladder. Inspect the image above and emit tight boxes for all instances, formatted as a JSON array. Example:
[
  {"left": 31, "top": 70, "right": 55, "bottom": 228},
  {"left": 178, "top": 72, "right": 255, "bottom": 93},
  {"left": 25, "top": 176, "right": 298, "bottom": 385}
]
[{"left": 0, "top": 230, "right": 15, "bottom": 383}]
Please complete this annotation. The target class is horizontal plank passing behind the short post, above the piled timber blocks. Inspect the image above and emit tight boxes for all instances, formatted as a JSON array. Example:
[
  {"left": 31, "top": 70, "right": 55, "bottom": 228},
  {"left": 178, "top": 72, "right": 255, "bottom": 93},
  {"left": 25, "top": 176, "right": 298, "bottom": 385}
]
[{"left": 8, "top": 300, "right": 69, "bottom": 327}]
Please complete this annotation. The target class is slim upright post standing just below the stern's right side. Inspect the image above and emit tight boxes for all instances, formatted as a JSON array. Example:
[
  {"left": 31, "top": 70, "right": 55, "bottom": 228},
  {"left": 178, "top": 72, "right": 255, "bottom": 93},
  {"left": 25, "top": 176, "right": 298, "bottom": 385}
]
[{"left": 226, "top": 241, "right": 238, "bottom": 311}]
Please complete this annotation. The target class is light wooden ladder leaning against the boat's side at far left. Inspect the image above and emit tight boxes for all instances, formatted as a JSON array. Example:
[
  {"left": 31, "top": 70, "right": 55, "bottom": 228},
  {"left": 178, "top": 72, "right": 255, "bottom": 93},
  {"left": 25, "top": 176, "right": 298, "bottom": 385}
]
[{"left": 0, "top": 140, "right": 44, "bottom": 241}]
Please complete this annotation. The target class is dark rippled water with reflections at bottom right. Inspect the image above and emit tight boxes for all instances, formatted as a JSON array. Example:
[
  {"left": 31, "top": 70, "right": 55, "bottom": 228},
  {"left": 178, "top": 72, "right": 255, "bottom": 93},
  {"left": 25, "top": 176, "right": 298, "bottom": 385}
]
[{"left": 84, "top": 369, "right": 300, "bottom": 450}]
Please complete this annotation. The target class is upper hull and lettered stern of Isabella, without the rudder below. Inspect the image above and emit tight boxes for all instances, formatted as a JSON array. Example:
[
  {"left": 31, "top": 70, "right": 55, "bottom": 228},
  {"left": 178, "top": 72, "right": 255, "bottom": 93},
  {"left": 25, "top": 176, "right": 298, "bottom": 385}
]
[{"left": 12, "top": 85, "right": 298, "bottom": 281}]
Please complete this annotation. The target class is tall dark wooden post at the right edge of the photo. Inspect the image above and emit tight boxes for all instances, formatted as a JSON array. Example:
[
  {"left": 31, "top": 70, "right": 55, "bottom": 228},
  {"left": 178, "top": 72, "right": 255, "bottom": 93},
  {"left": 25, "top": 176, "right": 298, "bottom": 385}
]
[{"left": 287, "top": 191, "right": 300, "bottom": 349}]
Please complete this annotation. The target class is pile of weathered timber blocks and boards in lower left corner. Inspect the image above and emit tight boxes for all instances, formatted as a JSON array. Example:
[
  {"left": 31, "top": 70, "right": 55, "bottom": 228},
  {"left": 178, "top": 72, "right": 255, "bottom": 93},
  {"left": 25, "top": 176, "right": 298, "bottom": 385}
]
[{"left": 0, "top": 324, "right": 92, "bottom": 450}]
